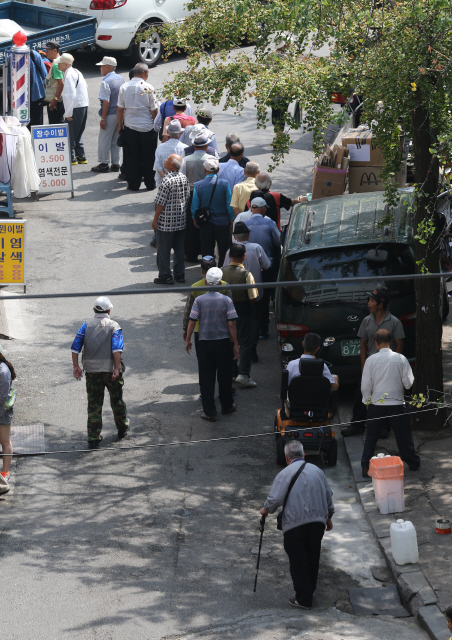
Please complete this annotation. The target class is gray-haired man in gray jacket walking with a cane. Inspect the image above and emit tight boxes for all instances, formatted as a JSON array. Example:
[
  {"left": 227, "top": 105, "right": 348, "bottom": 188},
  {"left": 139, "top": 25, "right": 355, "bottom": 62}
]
[{"left": 260, "top": 441, "right": 334, "bottom": 609}]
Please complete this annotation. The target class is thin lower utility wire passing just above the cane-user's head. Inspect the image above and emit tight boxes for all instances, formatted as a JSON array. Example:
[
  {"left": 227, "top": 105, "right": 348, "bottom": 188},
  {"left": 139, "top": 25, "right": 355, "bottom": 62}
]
[{"left": 1, "top": 403, "right": 452, "bottom": 458}]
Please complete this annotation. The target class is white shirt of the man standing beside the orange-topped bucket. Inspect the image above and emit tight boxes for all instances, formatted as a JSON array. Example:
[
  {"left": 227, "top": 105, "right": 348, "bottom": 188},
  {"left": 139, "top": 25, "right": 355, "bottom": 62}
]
[{"left": 361, "top": 349, "right": 414, "bottom": 406}]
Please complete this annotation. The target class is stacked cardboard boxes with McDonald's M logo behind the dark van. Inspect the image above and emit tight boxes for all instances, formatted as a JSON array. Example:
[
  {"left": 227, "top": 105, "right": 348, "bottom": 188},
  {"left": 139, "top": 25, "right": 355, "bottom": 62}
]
[{"left": 342, "top": 127, "right": 407, "bottom": 193}]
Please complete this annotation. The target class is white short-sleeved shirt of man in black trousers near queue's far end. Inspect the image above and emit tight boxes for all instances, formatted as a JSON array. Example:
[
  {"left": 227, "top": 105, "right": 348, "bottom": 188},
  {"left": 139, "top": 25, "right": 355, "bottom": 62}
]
[{"left": 118, "top": 78, "right": 158, "bottom": 131}]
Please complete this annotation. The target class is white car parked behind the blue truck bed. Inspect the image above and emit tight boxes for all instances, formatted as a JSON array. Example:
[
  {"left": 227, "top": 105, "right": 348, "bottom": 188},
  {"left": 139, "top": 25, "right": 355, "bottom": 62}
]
[{"left": 33, "top": 0, "right": 188, "bottom": 67}]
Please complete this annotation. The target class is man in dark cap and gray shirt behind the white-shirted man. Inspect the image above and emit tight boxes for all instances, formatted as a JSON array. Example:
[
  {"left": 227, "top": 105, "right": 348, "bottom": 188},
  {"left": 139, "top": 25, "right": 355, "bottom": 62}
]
[{"left": 341, "top": 289, "right": 405, "bottom": 438}]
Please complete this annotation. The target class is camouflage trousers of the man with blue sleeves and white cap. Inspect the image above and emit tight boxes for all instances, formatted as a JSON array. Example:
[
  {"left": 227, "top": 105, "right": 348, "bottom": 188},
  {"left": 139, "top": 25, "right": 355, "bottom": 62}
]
[{"left": 85, "top": 372, "right": 128, "bottom": 441}]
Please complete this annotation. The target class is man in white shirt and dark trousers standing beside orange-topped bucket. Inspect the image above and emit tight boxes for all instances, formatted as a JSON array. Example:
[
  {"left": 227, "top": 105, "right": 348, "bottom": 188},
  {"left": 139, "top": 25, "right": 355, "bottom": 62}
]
[{"left": 361, "top": 329, "right": 420, "bottom": 478}]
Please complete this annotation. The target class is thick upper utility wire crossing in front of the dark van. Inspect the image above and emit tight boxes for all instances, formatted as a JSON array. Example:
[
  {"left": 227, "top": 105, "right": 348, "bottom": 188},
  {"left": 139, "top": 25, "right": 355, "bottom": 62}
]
[{"left": 1, "top": 272, "right": 452, "bottom": 300}]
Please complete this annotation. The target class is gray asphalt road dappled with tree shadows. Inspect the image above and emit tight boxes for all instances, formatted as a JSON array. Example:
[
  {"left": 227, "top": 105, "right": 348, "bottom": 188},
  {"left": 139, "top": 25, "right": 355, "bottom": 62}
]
[{"left": 0, "top": 46, "right": 425, "bottom": 640}]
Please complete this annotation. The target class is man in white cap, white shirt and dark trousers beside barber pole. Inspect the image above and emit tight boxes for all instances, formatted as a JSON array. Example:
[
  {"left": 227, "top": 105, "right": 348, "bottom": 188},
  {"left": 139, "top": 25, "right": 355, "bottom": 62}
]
[{"left": 58, "top": 53, "right": 89, "bottom": 164}]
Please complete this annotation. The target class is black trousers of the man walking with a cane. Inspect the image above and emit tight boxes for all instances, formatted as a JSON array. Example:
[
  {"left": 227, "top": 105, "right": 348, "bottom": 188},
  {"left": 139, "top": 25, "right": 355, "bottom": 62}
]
[{"left": 284, "top": 522, "right": 325, "bottom": 607}]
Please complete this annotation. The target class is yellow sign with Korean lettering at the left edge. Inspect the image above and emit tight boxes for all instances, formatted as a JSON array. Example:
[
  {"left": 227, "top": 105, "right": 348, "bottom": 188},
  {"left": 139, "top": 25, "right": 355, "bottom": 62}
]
[{"left": 0, "top": 220, "right": 27, "bottom": 286}]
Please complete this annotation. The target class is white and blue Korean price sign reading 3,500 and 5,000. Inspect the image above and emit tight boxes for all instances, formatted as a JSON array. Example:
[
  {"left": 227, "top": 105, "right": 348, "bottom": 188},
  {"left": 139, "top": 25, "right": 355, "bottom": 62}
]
[{"left": 31, "top": 124, "right": 73, "bottom": 194}]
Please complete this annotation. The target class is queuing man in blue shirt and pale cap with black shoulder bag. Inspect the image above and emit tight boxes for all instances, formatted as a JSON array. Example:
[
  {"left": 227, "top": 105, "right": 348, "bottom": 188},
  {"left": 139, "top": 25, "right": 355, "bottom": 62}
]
[{"left": 191, "top": 157, "right": 234, "bottom": 264}]
